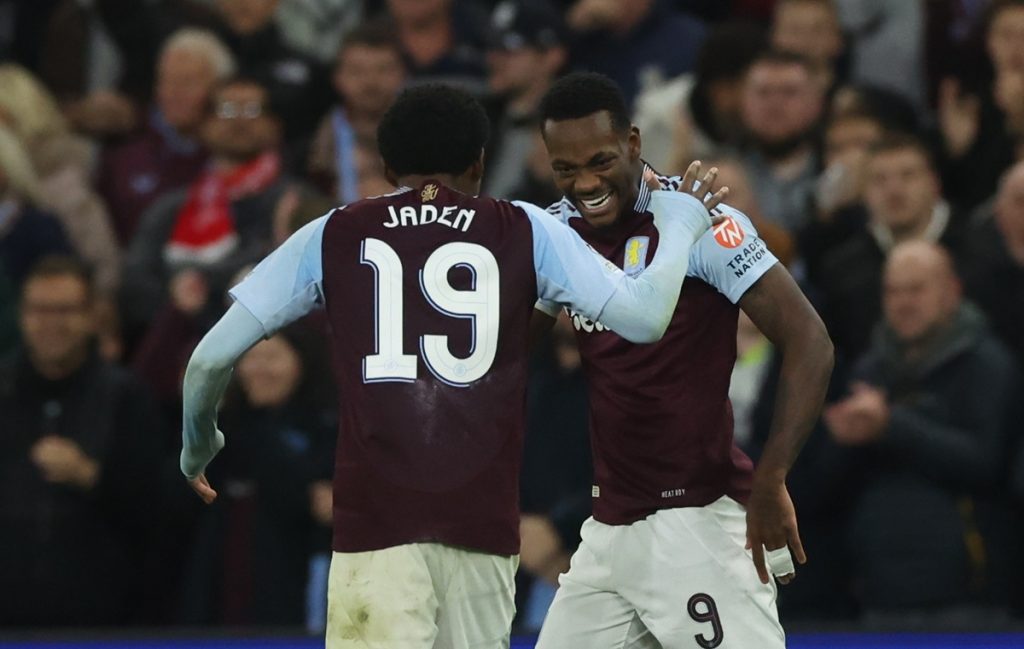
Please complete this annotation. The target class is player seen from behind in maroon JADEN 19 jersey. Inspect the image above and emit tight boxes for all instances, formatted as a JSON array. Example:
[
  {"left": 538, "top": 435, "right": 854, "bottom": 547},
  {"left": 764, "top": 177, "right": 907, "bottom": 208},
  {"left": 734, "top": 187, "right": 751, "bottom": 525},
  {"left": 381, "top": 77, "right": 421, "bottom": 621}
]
[{"left": 181, "top": 85, "right": 724, "bottom": 649}]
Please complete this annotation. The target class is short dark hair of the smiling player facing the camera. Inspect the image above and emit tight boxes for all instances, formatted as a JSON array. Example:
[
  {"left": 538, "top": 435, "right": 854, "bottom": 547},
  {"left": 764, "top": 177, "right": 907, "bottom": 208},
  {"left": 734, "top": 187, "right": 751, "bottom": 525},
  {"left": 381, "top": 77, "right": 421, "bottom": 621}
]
[{"left": 540, "top": 72, "right": 632, "bottom": 133}]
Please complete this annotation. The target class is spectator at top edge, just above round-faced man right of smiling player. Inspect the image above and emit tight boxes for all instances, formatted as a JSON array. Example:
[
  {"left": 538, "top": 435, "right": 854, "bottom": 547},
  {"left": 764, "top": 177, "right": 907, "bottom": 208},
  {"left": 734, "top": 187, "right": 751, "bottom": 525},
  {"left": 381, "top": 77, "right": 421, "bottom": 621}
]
[{"left": 771, "top": 0, "right": 849, "bottom": 92}]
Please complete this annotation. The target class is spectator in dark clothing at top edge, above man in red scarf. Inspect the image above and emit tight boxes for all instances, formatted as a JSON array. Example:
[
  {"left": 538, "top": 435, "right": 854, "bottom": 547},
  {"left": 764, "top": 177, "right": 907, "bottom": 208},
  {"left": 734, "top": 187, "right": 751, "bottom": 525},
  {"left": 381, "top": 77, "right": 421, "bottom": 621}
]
[{"left": 216, "top": 0, "right": 331, "bottom": 146}]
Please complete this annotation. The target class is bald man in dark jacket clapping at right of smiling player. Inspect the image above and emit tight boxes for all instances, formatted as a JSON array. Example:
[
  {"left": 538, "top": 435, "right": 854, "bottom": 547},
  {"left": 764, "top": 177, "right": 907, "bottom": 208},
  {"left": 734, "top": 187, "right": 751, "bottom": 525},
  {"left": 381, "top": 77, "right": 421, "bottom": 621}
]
[{"left": 824, "top": 241, "right": 1021, "bottom": 630}]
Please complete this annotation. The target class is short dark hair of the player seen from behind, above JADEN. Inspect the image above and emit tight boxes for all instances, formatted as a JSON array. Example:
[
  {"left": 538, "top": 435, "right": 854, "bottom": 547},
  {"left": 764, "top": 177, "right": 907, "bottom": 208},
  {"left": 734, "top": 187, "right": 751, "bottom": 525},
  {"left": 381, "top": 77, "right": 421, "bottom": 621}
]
[{"left": 377, "top": 84, "right": 490, "bottom": 176}]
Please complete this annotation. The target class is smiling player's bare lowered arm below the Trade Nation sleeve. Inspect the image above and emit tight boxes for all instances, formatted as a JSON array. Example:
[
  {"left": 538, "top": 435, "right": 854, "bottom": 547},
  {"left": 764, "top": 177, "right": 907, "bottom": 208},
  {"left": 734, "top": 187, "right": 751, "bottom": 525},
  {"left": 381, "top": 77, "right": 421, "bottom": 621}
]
[{"left": 738, "top": 264, "right": 834, "bottom": 583}]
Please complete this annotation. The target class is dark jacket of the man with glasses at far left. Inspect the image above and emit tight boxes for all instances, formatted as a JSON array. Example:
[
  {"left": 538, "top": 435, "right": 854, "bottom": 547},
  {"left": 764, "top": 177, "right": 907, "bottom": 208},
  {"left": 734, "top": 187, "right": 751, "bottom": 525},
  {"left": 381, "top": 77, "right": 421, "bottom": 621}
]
[{"left": 0, "top": 353, "right": 163, "bottom": 628}]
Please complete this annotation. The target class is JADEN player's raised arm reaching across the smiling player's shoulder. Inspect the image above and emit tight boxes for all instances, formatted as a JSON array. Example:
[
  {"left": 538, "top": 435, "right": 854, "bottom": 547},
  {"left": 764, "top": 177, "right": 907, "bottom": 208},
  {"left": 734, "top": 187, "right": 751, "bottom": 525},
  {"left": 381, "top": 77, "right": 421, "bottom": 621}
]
[{"left": 520, "top": 164, "right": 727, "bottom": 343}]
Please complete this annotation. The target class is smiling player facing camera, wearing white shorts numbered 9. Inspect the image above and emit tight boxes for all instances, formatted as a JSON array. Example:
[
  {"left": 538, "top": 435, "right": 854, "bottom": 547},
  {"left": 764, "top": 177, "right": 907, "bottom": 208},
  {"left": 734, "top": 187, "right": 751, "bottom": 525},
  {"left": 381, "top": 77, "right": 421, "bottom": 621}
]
[{"left": 535, "top": 73, "right": 833, "bottom": 649}]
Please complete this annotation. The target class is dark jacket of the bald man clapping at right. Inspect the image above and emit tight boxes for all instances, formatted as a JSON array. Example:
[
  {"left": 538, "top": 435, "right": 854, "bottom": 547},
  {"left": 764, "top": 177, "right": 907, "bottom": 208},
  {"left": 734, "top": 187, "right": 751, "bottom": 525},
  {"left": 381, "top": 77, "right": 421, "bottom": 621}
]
[{"left": 849, "top": 305, "right": 1021, "bottom": 612}]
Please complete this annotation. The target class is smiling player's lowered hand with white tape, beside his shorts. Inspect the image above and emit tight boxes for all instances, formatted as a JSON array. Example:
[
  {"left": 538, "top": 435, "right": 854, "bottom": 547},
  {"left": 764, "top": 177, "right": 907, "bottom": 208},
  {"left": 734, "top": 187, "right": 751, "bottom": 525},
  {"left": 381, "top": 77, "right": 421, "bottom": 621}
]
[{"left": 746, "top": 480, "right": 807, "bottom": 583}]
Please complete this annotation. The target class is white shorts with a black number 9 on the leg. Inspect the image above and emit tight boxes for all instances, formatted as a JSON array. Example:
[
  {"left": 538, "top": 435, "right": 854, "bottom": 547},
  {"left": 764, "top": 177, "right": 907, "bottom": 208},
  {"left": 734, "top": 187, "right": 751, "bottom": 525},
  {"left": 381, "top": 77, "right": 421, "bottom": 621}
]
[{"left": 537, "top": 497, "right": 785, "bottom": 649}]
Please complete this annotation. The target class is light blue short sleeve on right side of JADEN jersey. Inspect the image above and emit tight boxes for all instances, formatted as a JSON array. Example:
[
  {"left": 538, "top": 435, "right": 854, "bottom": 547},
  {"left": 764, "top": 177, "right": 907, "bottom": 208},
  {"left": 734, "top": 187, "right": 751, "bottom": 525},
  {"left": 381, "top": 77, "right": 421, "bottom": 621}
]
[{"left": 514, "top": 201, "right": 626, "bottom": 320}]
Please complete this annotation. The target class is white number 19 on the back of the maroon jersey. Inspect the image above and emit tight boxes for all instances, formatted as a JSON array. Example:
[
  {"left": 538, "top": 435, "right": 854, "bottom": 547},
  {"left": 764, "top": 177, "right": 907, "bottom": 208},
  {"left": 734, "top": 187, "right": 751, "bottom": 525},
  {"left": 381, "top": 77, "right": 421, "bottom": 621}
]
[{"left": 359, "top": 239, "right": 501, "bottom": 387}]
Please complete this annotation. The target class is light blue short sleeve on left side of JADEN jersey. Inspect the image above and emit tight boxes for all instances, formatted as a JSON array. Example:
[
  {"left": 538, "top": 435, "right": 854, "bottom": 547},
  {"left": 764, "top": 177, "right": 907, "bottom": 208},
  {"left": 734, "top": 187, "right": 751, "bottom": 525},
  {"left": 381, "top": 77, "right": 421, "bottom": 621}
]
[{"left": 229, "top": 214, "right": 331, "bottom": 336}]
